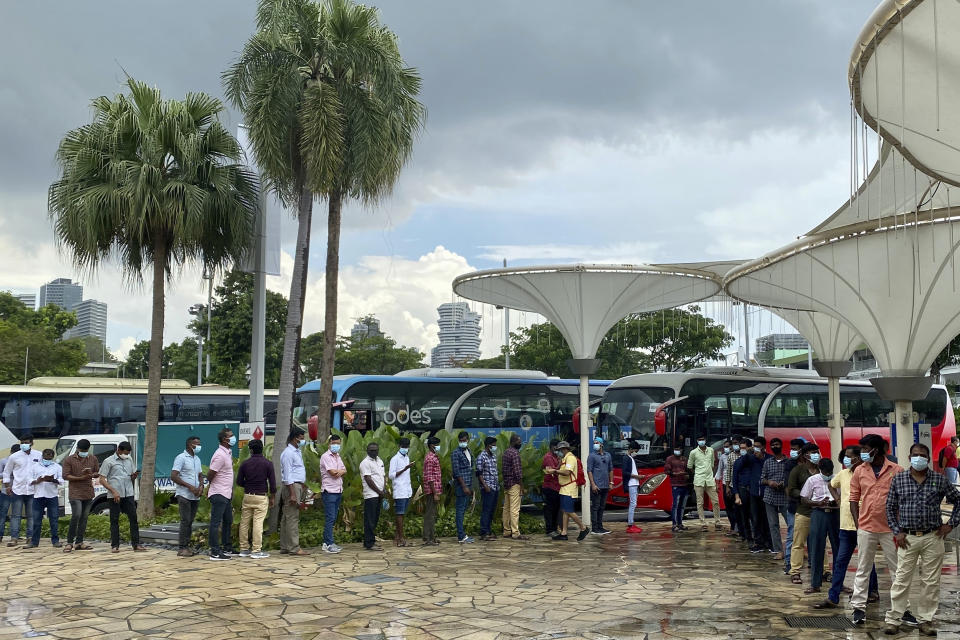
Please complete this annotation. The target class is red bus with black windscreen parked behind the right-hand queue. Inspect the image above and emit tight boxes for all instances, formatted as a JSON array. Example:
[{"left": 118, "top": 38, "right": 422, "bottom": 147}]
[{"left": 597, "top": 367, "right": 957, "bottom": 511}]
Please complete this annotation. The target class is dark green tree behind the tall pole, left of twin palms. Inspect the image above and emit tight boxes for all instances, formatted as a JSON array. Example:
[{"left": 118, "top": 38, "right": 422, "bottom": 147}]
[{"left": 190, "top": 269, "right": 287, "bottom": 389}]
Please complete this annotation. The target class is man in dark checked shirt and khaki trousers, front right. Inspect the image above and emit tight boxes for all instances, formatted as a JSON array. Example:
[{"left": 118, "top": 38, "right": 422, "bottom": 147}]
[{"left": 883, "top": 443, "right": 960, "bottom": 636}]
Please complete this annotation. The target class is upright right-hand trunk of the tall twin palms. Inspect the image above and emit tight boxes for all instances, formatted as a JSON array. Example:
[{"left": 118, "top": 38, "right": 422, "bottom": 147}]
[{"left": 317, "top": 190, "right": 343, "bottom": 442}]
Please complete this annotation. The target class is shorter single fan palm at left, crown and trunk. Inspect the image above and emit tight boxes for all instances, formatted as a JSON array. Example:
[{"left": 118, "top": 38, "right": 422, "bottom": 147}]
[{"left": 48, "top": 78, "right": 258, "bottom": 518}]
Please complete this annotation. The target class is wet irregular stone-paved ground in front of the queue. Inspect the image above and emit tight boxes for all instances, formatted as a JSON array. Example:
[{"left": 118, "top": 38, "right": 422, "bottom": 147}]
[{"left": 0, "top": 522, "right": 960, "bottom": 640}]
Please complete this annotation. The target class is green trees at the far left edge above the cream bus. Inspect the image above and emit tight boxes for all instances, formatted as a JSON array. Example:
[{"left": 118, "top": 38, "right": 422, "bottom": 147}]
[{"left": 0, "top": 292, "right": 87, "bottom": 384}]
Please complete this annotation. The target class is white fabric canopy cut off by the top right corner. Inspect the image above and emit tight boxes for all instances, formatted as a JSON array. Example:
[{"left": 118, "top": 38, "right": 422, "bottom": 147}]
[{"left": 849, "top": 0, "right": 960, "bottom": 186}]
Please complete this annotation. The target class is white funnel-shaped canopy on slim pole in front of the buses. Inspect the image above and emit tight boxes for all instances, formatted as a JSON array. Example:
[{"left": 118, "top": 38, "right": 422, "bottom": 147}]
[{"left": 453, "top": 263, "right": 720, "bottom": 524}]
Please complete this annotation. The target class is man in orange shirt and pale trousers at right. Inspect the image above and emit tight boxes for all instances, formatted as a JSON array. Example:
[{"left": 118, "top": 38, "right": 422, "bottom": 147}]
[{"left": 850, "top": 434, "right": 903, "bottom": 625}]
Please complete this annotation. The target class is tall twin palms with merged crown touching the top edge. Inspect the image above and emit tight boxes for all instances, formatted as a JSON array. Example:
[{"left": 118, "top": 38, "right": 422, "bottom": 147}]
[{"left": 223, "top": 0, "right": 426, "bottom": 460}]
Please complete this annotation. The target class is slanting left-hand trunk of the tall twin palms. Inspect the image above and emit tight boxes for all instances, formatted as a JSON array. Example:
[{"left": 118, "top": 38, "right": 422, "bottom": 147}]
[{"left": 269, "top": 175, "right": 313, "bottom": 531}]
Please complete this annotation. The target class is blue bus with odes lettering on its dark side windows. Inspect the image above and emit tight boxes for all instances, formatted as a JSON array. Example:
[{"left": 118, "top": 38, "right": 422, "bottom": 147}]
[{"left": 293, "top": 368, "right": 610, "bottom": 442}]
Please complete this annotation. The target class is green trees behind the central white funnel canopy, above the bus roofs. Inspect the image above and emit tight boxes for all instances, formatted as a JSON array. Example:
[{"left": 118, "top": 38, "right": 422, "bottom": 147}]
[{"left": 480, "top": 307, "right": 733, "bottom": 379}]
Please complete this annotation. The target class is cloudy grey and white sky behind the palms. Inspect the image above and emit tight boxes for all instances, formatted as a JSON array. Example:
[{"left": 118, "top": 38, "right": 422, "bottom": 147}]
[{"left": 0, "top": 0, "right": 876, "bottom": 354}]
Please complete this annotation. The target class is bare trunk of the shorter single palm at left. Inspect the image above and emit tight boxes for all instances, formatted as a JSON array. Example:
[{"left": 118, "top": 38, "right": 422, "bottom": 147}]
[{"left": 137, "top": 234, "right": 167, "bottom": 520}]
